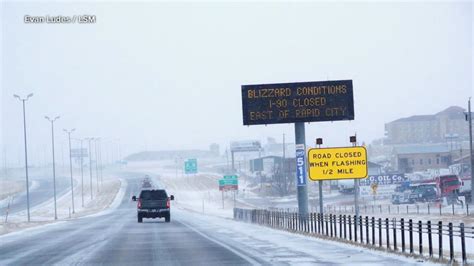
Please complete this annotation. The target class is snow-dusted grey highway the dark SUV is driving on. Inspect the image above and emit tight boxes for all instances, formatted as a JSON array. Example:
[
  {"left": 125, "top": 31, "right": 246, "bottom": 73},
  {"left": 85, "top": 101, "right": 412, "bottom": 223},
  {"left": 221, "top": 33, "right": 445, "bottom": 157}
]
[{"left": 0, "top": 174, "right": 432, "bottom": 265}]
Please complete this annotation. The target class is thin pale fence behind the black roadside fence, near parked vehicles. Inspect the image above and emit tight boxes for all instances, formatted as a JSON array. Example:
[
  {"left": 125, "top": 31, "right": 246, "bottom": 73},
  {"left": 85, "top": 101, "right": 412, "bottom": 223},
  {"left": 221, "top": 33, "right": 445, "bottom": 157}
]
[{"left": 324, "top": 203, "right": 473, "bottom": 216}]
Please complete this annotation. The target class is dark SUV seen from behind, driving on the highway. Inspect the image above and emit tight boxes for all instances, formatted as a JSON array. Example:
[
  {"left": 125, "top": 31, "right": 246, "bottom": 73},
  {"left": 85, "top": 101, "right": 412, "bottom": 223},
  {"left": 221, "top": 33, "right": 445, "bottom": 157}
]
[{"left": 132, "top": 189, "right": 174, "bottom": 223}]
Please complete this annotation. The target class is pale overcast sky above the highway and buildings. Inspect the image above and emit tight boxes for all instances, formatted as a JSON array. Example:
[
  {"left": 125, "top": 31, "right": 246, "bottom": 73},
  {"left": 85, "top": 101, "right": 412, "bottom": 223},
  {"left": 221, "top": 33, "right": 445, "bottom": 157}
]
[{"left": 0, "top": 2, "right": 473, "bottom": 164}]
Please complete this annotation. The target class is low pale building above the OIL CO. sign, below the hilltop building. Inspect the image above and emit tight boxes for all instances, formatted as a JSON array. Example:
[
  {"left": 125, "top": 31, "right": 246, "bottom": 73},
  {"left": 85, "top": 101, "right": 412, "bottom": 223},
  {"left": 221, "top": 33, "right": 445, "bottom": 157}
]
[{"left": 392, "top": 144, "right": 452, "bottom": 173}]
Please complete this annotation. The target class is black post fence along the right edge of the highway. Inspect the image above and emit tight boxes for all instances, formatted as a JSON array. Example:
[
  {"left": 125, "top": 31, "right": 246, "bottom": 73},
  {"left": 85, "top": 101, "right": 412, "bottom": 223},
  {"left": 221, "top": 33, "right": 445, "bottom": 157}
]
[{"left": 234, "top": 208, "right": 474, "bottom": 264}]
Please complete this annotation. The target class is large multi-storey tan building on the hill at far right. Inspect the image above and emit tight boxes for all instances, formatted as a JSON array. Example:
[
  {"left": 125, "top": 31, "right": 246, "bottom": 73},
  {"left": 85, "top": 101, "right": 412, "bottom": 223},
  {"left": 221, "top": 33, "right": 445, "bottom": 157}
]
[{"left": 384, "top": 106, "right": 469, "bottom": 145}]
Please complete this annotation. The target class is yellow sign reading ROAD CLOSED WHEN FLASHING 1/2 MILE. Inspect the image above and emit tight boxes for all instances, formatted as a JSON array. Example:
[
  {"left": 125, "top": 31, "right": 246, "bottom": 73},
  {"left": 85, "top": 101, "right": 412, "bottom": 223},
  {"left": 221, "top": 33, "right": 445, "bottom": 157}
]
[{"left": 308, "top": 147, "right": 368, "bottom": 181}]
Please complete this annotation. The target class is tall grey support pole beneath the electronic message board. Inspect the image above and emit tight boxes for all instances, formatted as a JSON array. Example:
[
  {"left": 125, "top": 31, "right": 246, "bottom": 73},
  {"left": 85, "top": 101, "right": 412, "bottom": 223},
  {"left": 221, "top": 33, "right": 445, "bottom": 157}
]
[{"left": 295, "top": 122, "right": 308, "bottom": 217}]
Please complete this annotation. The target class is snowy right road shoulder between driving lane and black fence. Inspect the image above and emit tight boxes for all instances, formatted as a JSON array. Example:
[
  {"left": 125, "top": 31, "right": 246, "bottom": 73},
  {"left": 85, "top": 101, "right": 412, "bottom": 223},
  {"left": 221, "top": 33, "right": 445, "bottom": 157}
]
[{"left": 175, "top": 211, "right": 432, "bottom": 265}]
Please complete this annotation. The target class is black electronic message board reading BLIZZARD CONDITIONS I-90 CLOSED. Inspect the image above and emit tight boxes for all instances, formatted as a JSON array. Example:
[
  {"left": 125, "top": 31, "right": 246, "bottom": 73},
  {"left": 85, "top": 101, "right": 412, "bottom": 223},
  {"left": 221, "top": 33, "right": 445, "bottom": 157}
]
[{"left": 242, "top": 80, "right": 354, "bottom": 125}]
